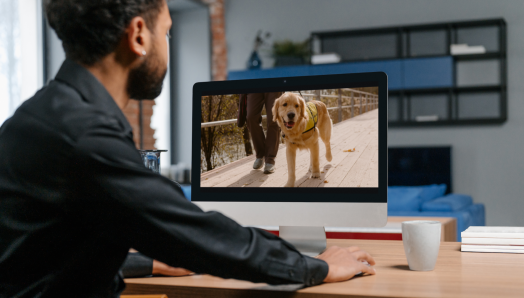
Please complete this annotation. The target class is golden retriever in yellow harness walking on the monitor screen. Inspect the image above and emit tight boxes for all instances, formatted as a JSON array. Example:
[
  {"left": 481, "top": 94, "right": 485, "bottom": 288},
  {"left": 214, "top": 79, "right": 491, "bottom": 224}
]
[{"left": 272, "top": 92, "right": 333, "bottom": 187}]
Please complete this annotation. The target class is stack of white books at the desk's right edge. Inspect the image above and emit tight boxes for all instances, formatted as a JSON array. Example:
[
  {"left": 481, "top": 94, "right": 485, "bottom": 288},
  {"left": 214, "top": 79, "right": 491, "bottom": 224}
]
[{"left": 461, "top": 227, "right": 524, "bottom": 253}]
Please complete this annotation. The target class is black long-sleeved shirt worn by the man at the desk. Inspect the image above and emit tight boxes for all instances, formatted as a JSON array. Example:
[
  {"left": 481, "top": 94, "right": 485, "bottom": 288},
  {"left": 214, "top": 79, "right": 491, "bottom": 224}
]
[{"left": 0, "top": 60, "right": 328, "bottom": 298}]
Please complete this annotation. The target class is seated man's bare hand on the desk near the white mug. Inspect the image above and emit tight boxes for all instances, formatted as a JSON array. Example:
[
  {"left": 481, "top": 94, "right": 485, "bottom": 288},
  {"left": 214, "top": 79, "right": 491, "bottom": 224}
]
[{"left": 317, "top": 246, "right": 375, "bottom": 282}]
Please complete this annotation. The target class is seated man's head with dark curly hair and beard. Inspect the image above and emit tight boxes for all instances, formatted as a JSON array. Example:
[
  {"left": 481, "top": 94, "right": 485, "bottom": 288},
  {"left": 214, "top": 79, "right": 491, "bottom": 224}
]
[{"left": 46, "top": 0, "right": 171, "bottom": 99}]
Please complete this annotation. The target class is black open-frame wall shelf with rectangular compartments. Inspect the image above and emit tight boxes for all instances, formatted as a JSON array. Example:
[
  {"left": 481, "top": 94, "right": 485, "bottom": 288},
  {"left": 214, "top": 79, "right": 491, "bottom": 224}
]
[{"left": 311, "top": 18, "right": 508, "bottom": 127}]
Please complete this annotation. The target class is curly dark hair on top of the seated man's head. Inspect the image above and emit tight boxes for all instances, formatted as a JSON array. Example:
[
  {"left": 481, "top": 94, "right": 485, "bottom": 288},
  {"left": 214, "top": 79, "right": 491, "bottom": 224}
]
[{"left": 45, "top": 0, "right": 165, "bottom": 65}]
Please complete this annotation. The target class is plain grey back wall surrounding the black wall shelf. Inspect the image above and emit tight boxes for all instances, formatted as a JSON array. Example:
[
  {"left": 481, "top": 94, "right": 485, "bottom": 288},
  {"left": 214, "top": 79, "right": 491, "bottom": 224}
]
[{"left": 226, "top": 0, "right": 524, "bottom": 226}]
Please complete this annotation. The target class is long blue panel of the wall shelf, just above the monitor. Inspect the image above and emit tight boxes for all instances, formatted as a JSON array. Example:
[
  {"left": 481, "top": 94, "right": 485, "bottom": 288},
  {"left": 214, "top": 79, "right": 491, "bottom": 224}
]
[{"left": 228, "top": 56, "right": 453, "bottom": 90}]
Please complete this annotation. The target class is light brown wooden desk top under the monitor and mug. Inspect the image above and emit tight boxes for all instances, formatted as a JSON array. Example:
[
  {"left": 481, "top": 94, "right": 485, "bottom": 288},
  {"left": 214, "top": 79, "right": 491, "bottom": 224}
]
[{"left": 124, "top": 239, "right": 524, "bottom": 298}]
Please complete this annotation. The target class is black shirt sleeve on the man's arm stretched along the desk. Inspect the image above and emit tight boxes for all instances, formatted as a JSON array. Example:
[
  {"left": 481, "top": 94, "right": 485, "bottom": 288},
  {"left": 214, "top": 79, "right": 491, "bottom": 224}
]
[{"left": 75, "top": 124, "right": 328, "bottom": 285}]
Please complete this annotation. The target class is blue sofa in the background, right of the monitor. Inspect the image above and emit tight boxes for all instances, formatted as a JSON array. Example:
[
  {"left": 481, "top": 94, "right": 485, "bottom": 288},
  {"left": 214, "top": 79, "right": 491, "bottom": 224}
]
[{"left": 388, "top": 184, "right": 486, "bottom": 242}]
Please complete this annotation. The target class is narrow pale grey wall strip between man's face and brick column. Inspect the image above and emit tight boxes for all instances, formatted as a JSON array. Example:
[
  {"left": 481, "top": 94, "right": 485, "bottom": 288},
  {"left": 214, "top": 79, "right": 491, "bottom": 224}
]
[{"left": 171, "top": 8, "right": 211, "bottom": 165}]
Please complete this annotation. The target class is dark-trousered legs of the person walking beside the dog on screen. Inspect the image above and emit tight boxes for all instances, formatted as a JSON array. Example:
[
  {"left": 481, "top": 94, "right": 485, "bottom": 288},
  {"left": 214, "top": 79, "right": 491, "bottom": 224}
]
[{"left": 246, "top": 92, "right": 282, "bottom": 174}]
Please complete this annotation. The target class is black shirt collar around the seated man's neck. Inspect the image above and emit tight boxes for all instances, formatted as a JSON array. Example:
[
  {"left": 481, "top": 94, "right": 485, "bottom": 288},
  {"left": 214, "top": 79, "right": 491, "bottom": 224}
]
[{"left": 55, "top": 59, "right": 133, "bottom": 132}]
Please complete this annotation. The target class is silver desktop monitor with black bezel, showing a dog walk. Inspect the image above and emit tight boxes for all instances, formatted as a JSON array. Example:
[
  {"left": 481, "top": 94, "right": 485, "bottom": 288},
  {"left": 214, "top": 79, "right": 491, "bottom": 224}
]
[{"left": 191, "top": 72, "right": 388, "bottom": 254}]
